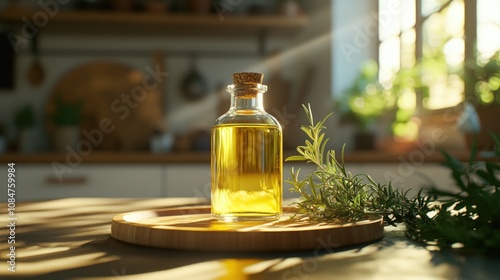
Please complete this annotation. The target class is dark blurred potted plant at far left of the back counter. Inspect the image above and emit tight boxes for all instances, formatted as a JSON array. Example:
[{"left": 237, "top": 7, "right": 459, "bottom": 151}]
[{"left": 14, "top": 104, "right": 35, "bottom": 153}]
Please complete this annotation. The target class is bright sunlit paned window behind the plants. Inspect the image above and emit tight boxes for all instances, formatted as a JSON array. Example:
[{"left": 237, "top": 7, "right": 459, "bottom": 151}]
[{"left": 378, "top": 0, "right": 500, "bottom": 136}]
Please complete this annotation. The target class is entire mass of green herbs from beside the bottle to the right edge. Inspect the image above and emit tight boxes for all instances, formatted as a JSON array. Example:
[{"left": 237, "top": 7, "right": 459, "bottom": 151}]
[{"left": 286, "top": 105, "right": 500, "bottom": 254}]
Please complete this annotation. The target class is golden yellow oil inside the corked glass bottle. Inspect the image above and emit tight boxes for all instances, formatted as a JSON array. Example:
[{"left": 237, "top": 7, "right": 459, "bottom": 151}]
[{"left": 211, "top": 124, "right": 283, "bottom": 221}]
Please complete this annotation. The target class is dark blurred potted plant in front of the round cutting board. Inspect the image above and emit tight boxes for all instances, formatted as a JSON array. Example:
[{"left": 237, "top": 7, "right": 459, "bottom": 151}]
[{"left": 50, "top": 96, "right": 82, "bottom": 152}]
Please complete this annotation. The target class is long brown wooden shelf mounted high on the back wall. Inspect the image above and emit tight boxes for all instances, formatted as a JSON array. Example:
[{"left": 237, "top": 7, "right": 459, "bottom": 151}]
[{"left": 0, "top": 7, "right": 308, "bottom": 34}]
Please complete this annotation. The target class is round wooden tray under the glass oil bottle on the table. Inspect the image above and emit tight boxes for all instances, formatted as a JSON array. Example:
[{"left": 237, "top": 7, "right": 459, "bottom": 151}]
[{"left": 111, "top": 206, "right": 384, "bottom": 252}]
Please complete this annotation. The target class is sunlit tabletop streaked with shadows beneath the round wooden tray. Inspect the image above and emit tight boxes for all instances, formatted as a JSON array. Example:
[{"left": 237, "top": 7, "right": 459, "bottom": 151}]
[{"left": 0, "top": 198, "right": 500, "bottom": 280}]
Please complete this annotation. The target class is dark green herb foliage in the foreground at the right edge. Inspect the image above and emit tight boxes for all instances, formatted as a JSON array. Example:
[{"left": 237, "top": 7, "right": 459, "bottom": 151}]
[{"left": 417, "top": 144, "right": 500, "bottom": 254}]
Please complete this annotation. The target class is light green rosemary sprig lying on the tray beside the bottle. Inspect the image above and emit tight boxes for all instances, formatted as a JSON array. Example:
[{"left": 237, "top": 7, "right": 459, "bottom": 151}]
[{"left": 286, "top": 105, "right": 411, "bottom": 224}]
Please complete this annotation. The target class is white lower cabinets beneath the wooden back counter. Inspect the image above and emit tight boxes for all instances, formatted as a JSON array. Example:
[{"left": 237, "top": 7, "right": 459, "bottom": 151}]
[{"left": 0, "top": 162, "right": 453, "bottom": 203}]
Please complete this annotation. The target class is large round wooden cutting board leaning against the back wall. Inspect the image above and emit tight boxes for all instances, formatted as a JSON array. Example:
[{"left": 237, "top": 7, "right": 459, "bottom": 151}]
[{"left": 46, "top": 61, "right": 163, "bottom": 150}]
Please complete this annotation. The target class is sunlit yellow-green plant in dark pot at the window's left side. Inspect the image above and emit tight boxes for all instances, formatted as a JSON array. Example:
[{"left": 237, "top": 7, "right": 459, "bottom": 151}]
[{"left": 337, "top": 60, "right": 395, "bottom": 150}]
